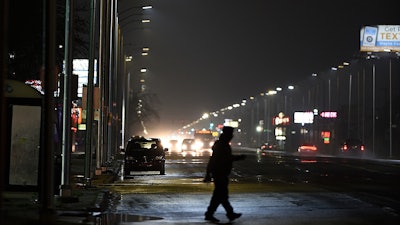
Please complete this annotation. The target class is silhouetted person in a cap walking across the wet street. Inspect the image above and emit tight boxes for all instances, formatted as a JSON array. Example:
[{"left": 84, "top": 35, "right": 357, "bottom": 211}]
[{"left": 204, "top": 126, "right": 246, "bottom": 222}]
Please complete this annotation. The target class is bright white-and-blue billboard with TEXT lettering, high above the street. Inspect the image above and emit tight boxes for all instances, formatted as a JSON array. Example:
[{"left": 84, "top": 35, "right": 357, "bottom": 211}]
[{"left": 360, "top": 25, "right": 400, "bottom": 52}]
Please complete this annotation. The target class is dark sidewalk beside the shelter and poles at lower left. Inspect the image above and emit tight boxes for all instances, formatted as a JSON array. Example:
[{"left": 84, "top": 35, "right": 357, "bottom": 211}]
[{"left": 0, "top": 156, "right": 116, "bottom": 225}]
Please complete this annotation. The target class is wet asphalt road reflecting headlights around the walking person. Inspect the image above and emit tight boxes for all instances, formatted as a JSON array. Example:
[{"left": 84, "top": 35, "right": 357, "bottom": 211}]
[{"left": 96, "top": 149, "right": 400, "bottom": 225}]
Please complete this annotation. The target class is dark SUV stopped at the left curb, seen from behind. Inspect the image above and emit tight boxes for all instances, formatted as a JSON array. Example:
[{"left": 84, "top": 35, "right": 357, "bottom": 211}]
[{"left": 124, "top": 136, "right": 168, "bottom": 176}]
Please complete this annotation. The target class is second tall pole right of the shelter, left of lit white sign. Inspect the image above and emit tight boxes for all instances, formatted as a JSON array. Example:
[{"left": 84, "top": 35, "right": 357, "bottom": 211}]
[{"left": 60, "top": 0, "right": 74, "bottom": 196}]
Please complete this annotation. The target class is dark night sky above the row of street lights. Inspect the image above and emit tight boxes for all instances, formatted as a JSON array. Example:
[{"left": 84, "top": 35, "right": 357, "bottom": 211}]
[{"left": 125, "top": 0, "right": 400, "bottom": 134}]
